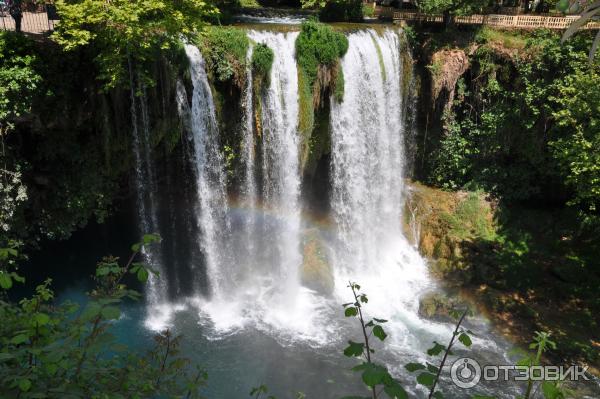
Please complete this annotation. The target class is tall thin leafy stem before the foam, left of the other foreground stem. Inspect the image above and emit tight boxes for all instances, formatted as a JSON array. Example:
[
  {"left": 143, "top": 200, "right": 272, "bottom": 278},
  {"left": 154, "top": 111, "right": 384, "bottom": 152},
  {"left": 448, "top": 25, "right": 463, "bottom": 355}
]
[{"left": 343, "top": 282, "right": 408, "bottom": 399}]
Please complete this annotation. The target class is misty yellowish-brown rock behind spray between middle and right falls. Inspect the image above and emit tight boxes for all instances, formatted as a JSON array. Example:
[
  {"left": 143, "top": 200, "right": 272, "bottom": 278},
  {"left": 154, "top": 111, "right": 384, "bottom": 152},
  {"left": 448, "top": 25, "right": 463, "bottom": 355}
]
[{"left": 300, "top": 229, "right": 335, "bottom": 295}]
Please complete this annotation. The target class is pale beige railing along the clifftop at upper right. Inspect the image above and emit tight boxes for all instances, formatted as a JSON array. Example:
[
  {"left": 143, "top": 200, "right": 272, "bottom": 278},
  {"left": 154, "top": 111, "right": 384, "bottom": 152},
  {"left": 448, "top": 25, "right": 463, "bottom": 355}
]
[{"left": 394, "top": 11, "right": 600, "bottom": 29}]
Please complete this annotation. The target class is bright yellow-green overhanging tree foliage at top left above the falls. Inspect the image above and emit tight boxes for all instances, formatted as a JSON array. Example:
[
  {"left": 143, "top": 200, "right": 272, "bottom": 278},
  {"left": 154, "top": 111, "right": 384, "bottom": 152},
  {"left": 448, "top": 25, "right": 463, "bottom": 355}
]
[{"left": 52, "top": 0, "right": 217, "bottom": 89}]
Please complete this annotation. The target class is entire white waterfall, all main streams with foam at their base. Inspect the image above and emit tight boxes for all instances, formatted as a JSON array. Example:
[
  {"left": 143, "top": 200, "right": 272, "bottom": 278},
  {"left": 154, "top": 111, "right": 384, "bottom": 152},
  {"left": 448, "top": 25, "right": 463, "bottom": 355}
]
[{"left": 148, "top": 30, "right": 446, "bottom": 347}]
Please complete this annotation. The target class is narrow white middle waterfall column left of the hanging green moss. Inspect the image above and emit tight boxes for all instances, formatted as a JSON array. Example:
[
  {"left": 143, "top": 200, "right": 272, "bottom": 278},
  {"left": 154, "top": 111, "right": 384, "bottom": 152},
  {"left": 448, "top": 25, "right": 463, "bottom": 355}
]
[{"left": 249, "top": 31, "right": 301, "bottom": 304}]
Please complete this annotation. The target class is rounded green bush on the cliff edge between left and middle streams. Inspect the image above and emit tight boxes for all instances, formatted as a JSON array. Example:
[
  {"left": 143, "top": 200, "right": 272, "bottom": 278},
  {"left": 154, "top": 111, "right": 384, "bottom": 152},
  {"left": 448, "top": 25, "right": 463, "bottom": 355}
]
[{"left": 198, "top": 27, "right": 250, "bottom": 87}]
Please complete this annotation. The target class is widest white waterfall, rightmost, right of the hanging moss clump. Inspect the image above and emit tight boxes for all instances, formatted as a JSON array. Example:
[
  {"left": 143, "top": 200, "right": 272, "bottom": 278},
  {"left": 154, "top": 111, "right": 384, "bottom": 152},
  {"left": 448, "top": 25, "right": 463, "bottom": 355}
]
[{"left": 331, "top": 30, "right": 446, "bottom": 347}]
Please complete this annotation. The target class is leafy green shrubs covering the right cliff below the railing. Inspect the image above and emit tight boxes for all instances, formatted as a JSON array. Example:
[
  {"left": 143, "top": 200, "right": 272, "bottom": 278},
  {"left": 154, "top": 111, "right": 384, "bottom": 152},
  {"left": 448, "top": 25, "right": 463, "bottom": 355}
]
[{"left": 430, "top": 31, "right": 599, "bottom": 217}]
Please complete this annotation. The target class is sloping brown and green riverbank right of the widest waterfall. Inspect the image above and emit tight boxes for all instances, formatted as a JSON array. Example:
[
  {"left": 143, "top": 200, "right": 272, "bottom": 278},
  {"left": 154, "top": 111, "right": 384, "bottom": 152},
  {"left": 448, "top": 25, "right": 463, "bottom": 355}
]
[{"left": 406, "top": 183, "right": 600, "bottom": 375}]
